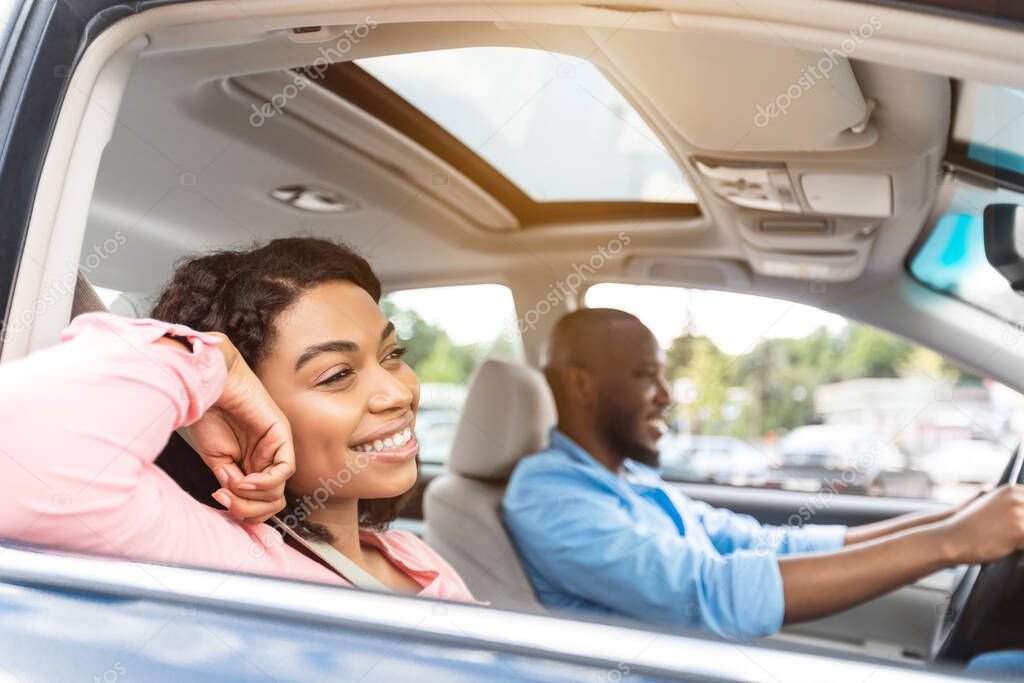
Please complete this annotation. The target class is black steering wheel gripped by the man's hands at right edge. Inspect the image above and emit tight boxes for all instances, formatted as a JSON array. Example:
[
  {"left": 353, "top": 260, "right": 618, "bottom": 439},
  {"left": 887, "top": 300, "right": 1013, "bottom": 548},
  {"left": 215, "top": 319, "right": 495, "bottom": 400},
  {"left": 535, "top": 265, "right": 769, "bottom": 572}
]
[{"left": 931, "top": 444, "right": 1024, "bottom": 661}]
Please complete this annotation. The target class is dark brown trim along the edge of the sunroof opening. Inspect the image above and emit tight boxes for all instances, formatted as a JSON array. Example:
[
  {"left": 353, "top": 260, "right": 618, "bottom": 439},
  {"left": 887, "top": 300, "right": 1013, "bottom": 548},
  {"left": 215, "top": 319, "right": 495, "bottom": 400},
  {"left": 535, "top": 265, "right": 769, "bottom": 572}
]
[{"left": 295, "top": 61, "right": 703, "bottom": 228}]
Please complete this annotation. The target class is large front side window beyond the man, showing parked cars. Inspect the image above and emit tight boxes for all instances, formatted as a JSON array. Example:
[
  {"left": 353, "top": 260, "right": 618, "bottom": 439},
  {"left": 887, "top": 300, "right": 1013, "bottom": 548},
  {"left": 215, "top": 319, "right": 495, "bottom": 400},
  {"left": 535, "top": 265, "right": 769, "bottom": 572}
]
[{"left": 585, "top": 284, "right": 1024, "bottom": 502}]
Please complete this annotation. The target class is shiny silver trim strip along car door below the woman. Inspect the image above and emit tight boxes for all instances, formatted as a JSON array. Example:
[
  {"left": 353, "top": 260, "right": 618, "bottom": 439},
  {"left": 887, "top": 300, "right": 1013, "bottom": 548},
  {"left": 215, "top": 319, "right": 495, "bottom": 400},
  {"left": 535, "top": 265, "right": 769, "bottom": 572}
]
[{"left": 0, "top": 544, "right": 961, "bottom": 683}]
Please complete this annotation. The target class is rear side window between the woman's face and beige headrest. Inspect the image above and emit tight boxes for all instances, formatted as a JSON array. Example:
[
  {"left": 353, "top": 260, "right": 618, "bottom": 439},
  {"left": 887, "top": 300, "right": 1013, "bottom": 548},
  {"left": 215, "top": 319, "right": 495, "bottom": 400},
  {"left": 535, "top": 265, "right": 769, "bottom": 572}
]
[{"left": 381, "top": 285, "right": 523, "bottom": 464}]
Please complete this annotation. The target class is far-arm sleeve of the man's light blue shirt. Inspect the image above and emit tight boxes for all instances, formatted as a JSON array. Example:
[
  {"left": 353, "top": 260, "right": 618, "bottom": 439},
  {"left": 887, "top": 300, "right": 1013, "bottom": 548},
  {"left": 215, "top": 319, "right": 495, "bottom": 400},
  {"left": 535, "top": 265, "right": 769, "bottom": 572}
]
[{"left": 689, "top": 501, "right": 848, "bottom": 555}]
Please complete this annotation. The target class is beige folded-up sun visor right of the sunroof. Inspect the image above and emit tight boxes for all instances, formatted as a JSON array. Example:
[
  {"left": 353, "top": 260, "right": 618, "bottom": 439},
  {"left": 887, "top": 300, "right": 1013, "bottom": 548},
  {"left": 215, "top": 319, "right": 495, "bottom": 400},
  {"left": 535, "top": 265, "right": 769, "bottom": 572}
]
[{"left": 589, "top": 26, "right": 878, "bottom": 153}]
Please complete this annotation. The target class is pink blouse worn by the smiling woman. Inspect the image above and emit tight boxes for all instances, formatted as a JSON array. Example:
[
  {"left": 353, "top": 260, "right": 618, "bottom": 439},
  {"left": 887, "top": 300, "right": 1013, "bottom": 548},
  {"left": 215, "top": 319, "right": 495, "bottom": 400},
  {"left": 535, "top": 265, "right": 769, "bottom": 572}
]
[{"left": 0, "top": 313, "right": 473, "bottom": 601}]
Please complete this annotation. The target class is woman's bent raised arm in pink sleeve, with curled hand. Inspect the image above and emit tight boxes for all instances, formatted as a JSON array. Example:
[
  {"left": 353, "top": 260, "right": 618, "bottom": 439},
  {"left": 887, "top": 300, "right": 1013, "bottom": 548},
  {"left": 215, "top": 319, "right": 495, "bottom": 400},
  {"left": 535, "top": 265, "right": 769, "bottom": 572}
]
[{"left": 0, "top": 313, "right": 293, "bottom": 568}]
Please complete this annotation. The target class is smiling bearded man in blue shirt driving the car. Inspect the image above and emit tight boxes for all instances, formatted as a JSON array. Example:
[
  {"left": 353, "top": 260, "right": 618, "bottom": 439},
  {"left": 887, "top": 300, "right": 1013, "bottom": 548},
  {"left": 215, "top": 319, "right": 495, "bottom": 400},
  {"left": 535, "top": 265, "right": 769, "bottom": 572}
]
[{"left": 504, "top": 308, "right": 1024, "bottom": 637}]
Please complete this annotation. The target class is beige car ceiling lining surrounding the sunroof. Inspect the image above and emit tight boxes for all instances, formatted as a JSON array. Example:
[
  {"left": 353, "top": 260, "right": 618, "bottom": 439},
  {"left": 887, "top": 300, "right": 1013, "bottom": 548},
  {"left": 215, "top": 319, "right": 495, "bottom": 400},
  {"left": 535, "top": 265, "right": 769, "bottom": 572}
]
[{"left": 79, "top": 4, "right": 950, "bottom": 313}]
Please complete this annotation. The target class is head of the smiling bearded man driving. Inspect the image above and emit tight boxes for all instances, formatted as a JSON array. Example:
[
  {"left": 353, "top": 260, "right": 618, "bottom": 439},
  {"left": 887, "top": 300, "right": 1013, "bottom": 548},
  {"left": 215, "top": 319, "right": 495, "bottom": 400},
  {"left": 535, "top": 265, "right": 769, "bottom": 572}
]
[{"left": 543, "top": 308, "right": 671, "bottom": 469}]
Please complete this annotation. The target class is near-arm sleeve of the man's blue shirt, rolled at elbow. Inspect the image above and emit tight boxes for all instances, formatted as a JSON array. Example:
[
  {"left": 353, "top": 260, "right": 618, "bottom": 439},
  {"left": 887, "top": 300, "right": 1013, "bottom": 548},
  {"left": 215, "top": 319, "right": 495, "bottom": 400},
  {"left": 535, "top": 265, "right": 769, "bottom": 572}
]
[{"left": 504, "top": 459, "right": 784, "bottom": 637}]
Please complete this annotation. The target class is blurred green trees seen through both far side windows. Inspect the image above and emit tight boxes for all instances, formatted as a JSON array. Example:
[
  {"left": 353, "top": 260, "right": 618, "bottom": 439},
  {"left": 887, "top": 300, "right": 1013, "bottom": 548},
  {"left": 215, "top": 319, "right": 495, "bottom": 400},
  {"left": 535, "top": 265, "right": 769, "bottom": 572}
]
[{"left": 381, "top": 299, "right": 977, "bottom": 438}]
